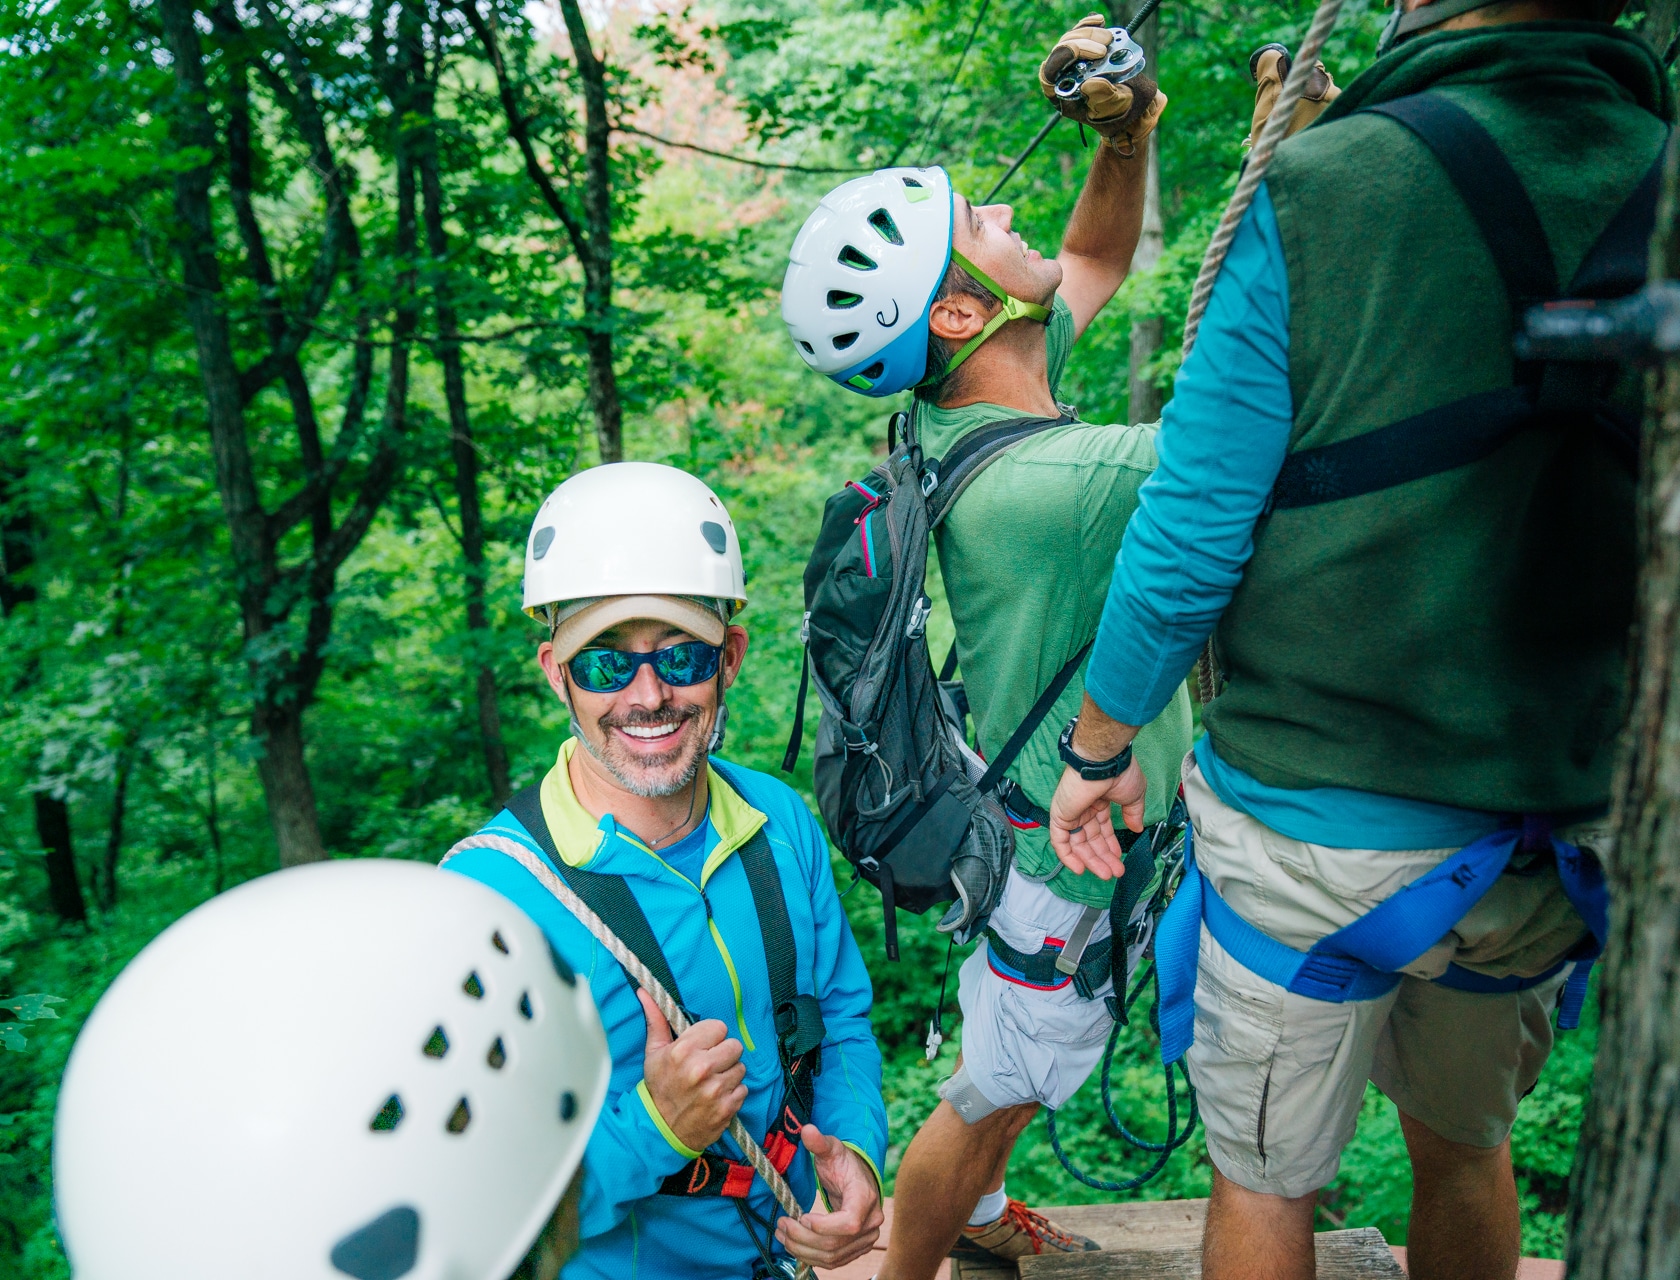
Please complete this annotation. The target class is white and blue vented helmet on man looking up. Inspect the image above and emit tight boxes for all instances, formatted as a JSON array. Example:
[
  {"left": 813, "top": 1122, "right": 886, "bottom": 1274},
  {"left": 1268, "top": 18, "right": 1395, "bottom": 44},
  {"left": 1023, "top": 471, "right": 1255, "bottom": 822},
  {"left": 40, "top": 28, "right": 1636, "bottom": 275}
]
[{"left": 781, "top": 166, "right": 953, "bottom": 396}]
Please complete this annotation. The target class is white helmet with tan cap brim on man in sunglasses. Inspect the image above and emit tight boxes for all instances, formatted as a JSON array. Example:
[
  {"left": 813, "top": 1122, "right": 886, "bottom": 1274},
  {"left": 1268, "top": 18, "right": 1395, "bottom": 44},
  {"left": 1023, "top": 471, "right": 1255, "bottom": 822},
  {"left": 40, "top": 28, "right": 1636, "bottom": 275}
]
[{"left": 524, "top": 462, "right": 746, "bottom": 662}]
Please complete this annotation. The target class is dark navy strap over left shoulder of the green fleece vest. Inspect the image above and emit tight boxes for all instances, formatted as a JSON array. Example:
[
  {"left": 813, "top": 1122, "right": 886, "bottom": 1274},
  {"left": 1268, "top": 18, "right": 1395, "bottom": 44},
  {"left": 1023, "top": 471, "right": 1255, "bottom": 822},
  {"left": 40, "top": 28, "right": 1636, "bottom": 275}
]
[{"left": 1364, "top": 92, "right": 1557, "bottom": 307}]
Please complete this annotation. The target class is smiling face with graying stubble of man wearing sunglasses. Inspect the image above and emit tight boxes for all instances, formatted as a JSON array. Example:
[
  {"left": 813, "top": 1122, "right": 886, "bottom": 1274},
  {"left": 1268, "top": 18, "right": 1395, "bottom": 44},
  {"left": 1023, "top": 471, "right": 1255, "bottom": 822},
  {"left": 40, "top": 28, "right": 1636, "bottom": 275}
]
[{"left": 539, "top": 620, "right": 746, "bottom": 796}]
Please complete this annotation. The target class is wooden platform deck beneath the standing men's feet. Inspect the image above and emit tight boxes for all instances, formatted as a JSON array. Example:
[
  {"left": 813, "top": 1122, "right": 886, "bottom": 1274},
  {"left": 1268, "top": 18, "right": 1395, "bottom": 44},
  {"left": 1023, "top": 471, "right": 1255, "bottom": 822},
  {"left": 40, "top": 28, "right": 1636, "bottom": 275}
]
[{"left": 818, "top": 1199, "right": 1564, "bottom": 1280}]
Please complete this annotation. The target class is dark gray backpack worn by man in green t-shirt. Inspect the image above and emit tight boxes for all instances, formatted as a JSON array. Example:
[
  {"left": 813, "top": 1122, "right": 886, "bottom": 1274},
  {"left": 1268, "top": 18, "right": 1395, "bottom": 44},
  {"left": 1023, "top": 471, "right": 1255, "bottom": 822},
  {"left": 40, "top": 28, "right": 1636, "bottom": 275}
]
[{"left": 781, "top": 412, "right": 1090, "bottom": 959}]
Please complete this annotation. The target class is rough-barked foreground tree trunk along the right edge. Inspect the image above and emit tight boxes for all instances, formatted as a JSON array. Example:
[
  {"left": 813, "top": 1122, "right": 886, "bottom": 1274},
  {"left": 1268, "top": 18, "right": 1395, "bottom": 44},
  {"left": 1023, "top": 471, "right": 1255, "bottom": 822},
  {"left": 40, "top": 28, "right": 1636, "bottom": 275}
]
[{"left": 1569, "top": 131, "right": 1680, "bottom": 1280}]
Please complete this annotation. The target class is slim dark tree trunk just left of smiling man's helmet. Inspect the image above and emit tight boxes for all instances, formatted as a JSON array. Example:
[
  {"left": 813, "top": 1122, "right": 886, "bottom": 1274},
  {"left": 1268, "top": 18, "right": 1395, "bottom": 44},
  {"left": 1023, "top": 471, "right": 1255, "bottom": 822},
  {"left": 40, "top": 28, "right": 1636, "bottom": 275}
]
[{"left": 418, "top": 92, "right": 512, "bottom": 808}]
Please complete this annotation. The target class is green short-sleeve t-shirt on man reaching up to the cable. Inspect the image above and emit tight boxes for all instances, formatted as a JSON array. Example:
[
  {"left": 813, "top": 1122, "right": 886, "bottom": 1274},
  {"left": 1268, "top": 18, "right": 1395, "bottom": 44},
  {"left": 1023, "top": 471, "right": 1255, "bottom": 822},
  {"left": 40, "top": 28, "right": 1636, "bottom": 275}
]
[{"left": 914, "top": 297, "right": 1191, "bottom": 905}]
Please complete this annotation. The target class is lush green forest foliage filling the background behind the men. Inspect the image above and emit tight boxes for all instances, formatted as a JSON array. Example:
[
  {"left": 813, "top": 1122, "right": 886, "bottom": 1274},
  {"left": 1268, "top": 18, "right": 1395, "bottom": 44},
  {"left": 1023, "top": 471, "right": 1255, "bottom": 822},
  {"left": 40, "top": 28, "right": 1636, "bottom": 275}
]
[{"left": 0, "top": 0, "right": 1594, "bottom": 1280}]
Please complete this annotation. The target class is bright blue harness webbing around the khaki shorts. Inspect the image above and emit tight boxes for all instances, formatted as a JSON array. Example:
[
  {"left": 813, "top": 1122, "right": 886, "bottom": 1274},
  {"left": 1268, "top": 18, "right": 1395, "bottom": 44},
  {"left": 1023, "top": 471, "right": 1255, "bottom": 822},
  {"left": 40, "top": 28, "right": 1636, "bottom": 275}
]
[{"left": 1156, "top": 820, "right": 1609, "bottom": 1063}]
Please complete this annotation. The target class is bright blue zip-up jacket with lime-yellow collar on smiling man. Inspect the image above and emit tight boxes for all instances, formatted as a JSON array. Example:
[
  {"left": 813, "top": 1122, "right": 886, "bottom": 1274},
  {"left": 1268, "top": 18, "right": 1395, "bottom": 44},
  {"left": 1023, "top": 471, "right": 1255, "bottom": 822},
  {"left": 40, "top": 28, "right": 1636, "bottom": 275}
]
[{"left": 449, "top": 739, "right": 887, "bottom": 1280}]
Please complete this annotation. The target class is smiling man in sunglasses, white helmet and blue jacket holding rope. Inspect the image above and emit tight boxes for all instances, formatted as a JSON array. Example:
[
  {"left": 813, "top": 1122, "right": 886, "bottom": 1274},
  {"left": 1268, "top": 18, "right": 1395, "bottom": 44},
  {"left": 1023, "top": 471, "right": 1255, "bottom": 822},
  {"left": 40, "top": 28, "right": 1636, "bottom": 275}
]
[{"left": 449, "top": 462, "right": 887, "bottom": 1280}]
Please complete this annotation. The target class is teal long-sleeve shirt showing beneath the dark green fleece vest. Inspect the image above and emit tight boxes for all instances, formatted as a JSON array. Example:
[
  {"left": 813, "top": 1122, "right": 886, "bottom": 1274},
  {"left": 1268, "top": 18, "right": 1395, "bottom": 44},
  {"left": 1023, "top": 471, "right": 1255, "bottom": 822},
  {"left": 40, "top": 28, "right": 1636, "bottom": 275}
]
[{"left": 1085, "top": 183, "right": 1500, "bottom": 848}]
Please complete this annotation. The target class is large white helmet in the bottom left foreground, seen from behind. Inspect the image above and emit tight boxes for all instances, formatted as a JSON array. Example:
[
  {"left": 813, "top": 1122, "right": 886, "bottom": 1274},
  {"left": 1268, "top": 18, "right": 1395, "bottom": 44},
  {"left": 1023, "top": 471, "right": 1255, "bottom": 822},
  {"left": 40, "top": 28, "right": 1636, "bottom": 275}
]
[{"left": 52, "top": 858, "right": 612, "bottom": 1280}]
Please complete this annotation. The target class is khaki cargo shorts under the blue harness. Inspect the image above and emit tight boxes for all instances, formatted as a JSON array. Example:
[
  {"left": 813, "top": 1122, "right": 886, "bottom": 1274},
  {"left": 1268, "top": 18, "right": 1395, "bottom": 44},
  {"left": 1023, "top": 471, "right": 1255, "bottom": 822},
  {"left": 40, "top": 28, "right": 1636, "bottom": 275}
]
[{"left": 1184, "top": 756, "right": 1604, "bottom": 1198}]
